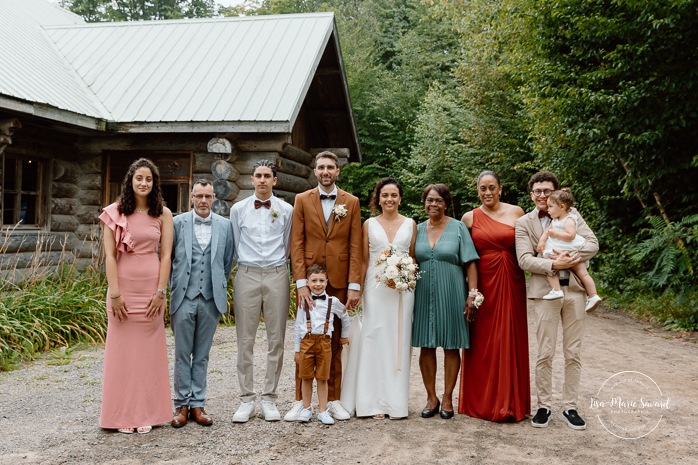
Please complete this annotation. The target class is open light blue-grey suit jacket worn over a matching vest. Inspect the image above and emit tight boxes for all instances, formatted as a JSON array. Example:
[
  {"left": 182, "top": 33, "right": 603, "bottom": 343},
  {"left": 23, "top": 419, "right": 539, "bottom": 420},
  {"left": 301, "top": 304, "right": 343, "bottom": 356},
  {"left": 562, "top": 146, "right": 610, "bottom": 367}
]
[{"left": 170, "top": 210, "right": 234, "bottom": 314}]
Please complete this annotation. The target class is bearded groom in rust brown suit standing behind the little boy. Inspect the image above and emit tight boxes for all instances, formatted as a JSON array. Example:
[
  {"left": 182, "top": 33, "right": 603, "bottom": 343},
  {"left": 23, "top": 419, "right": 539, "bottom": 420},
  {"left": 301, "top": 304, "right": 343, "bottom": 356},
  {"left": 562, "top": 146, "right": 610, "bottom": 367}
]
[{"left": 284, "top": 151, "right": 362, "bottom": 421}]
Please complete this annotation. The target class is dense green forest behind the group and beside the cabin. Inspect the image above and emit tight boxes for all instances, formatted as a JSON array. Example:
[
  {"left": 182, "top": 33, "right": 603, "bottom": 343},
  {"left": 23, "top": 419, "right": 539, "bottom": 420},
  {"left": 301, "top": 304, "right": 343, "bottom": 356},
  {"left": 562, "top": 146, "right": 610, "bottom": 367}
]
[{"left": 60, "top": 0, "right": 698, "bottom": 330}]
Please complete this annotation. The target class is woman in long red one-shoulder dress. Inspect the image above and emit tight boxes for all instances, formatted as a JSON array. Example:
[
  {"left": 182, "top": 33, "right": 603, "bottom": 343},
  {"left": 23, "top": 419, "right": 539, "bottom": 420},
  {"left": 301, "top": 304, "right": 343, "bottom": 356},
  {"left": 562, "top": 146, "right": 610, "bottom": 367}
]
[{"left": 458, "top": 171, "right": 531, "bottom": 421}]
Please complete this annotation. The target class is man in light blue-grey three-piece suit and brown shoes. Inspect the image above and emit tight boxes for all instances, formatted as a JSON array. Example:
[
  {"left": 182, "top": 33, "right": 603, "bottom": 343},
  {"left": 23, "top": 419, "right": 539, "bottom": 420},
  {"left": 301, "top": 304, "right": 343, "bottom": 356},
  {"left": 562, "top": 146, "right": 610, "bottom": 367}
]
[{"left": 170, "top": 179, "right": 233, "bottom": 428}]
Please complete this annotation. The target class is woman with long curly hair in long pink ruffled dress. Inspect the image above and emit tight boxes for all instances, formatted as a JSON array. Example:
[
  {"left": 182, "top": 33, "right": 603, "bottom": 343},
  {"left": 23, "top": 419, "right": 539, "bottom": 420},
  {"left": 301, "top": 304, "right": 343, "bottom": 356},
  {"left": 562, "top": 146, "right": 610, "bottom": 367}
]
[{"left": 99, "top": 158, "right": 174, "bottom": 434}]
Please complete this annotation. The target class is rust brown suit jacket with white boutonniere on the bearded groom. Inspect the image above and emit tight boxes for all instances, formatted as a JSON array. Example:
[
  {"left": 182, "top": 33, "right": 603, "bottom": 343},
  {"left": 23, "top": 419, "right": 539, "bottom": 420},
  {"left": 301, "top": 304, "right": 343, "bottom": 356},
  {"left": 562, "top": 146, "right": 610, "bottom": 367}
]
[{"left": 291, "top": 188, "right": 363, "bottom": 289}]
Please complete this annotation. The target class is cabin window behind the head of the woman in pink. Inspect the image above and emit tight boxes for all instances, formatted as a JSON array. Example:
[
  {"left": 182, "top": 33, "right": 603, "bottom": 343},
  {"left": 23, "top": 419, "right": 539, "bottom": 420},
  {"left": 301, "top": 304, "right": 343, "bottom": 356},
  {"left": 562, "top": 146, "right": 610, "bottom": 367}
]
[{"left": 104, "top": 152, "right": 192, "bottom": 215}]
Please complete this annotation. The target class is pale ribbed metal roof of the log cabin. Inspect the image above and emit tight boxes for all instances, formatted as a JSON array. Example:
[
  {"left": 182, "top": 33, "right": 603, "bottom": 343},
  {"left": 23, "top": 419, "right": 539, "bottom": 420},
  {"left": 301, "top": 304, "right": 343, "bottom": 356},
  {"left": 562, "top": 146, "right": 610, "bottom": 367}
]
[{"left": 0, "top": 0, "right": 344, "bottom": 132}]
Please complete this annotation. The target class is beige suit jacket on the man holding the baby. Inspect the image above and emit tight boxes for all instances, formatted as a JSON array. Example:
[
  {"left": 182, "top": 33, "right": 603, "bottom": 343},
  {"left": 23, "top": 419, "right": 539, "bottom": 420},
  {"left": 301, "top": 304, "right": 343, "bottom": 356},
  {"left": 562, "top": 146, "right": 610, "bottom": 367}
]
[{"left": 516, "top": 208, "right": 599, "bottom": 299}]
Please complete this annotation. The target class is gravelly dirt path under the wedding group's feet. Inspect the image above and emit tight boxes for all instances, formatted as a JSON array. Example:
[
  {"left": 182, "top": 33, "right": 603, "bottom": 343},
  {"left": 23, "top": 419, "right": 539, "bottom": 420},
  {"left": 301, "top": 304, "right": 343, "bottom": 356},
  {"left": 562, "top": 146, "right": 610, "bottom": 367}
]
[{"left": 0, "top": 310, "right": 698, "bottom": 465}]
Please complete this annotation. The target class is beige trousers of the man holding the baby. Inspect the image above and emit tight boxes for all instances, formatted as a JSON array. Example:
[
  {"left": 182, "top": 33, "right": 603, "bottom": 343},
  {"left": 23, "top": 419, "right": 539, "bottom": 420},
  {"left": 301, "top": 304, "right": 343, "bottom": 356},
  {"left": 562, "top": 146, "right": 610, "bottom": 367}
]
[{"left": 533, "top": 286, "right": 586, "bottom": 410}]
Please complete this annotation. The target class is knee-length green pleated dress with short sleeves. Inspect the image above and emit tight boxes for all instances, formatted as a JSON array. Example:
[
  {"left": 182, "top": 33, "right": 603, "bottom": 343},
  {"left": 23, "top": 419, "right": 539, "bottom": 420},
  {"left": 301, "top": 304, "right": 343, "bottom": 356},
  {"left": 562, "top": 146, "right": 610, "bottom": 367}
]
[{"left": 412, "top": 218, "right": 479, "bottom": 349}]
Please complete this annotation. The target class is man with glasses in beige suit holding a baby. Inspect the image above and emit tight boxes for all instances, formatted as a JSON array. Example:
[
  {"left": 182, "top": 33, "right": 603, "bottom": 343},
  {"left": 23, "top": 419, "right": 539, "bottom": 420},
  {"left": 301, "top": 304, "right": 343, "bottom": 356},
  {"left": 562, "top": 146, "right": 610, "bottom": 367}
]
[{"left": 516, "top": 171, "right": 599, "bottom": 429}]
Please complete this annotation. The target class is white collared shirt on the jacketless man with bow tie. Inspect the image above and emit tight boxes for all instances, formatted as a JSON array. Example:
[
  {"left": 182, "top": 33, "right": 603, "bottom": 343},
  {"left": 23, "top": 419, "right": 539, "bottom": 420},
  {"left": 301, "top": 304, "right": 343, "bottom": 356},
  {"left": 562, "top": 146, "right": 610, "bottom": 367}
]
[{"left": 230, "top": 195, "right": 293, "bottom": 268}]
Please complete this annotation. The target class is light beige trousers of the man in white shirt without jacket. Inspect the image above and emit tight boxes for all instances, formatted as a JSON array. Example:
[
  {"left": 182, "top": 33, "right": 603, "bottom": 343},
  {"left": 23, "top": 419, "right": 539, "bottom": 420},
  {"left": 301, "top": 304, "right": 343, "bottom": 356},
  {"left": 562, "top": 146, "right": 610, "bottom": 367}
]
[{"left": 233, "top": 265, "right": 290, "bottom": 402}]
